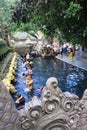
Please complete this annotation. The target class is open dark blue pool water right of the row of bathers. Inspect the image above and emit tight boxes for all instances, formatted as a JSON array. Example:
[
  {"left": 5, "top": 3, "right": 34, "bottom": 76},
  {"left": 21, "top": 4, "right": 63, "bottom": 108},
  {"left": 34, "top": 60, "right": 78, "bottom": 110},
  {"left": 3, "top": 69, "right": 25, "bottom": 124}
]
[{"left": 33, "top": 57, "right": 87, "bottom": 98}]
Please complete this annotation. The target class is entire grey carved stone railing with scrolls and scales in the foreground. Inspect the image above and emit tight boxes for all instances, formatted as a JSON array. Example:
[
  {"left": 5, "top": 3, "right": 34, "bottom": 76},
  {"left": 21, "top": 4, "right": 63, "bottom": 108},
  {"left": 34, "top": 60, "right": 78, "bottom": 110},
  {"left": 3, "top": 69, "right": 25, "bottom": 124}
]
[{"left": 0, "top": 77, "right": 87, "bottom": 130}]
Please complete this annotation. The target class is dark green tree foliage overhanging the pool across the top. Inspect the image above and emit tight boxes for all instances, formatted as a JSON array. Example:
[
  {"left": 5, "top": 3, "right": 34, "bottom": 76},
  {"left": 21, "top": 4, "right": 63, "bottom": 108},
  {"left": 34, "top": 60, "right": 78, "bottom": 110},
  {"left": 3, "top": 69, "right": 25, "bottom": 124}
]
[{"left": 12, "top": 0, "right": 87, "bottom": 44}]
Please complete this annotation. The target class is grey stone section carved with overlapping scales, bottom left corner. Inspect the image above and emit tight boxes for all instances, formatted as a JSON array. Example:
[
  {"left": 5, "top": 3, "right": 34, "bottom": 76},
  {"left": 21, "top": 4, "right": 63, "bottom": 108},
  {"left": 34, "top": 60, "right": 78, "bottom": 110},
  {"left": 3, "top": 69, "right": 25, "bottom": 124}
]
[{"left": 0, "top": 83, "right": 22, "bottom": 130}]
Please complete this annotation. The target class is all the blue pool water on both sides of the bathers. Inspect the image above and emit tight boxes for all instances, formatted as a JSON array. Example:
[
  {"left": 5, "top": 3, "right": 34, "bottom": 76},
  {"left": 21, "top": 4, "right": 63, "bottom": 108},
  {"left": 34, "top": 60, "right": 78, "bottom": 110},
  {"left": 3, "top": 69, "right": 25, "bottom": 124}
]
[{"left": 15, "top": 57, "right": 87, "bottom": 109}]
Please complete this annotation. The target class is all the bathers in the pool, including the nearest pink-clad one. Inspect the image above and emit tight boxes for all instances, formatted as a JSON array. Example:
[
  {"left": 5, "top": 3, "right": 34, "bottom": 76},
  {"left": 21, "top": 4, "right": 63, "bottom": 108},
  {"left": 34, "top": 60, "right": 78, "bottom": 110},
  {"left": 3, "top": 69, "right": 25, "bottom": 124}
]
[{"left": 15, "top": 53, "right": 45, "bottom": 106}]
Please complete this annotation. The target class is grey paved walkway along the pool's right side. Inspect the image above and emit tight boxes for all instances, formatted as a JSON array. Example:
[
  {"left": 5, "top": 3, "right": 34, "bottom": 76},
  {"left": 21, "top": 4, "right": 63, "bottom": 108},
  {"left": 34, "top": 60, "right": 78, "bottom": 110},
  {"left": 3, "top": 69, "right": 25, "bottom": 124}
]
[{"left": 56, "top": 51, "right": 87, "bottom": 71}]
